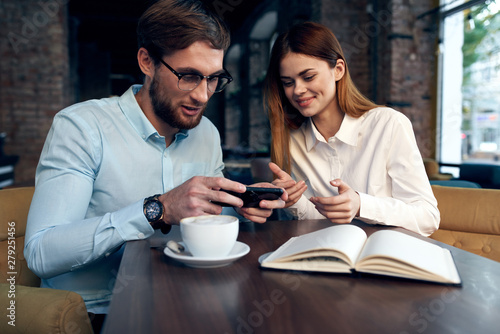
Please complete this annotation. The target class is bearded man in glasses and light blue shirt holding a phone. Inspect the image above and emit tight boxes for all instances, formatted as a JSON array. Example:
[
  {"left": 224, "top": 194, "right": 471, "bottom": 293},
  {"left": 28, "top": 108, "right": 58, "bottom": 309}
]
[{"left": 24, "top": 0, "right": 287, "bottom": 332}]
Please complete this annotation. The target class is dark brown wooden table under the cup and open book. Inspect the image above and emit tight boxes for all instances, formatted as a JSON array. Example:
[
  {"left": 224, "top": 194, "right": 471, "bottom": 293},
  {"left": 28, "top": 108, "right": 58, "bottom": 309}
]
[{"left": 100, "top": 220, "right": 500, "bottom": 334}]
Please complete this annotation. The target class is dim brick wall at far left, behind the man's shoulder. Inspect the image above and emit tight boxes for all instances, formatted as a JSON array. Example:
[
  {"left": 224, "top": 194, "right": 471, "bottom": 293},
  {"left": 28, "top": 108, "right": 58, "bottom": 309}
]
[{"left": 0, "top": 0, "right": 72, "bottom": 183}]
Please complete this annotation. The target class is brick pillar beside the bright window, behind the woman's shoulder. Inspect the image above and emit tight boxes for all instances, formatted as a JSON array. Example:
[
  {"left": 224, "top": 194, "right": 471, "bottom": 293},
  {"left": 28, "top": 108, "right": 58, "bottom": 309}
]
[{"left": 385, "top": 0, "right": 438, "bottom": 157}]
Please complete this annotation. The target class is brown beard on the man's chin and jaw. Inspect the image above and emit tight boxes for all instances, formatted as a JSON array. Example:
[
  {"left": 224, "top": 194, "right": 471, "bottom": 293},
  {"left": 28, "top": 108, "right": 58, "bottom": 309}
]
[{"left": 149, "top": 75, "right": 206, "bottom": 130}]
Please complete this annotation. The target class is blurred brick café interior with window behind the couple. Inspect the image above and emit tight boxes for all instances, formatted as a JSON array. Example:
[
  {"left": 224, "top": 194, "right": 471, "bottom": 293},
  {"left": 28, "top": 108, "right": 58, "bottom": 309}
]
[{"left": 0, "top": 0, "right": 500, "bottom": 188}]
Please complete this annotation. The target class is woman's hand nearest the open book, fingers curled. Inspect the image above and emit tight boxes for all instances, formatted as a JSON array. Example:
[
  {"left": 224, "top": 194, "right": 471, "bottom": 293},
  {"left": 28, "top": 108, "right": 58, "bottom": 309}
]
[{"left": 310, "top": 179, "right": 361, "bottom": 224}]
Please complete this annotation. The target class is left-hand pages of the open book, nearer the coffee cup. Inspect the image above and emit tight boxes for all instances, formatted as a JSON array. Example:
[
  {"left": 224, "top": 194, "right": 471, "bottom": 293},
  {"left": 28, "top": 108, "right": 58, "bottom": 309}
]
[{"left": 263, "top": 224, "right": 367, "bottom": 267}]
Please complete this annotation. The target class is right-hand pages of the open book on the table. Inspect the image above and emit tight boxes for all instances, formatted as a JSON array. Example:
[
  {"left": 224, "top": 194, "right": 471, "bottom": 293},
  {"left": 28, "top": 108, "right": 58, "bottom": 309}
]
[{"left": 356, "top": 230, "right": 461, "bottom": 284}]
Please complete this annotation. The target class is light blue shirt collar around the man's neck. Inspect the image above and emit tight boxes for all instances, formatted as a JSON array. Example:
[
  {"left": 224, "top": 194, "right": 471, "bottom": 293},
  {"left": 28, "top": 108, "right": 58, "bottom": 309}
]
[{"left": 118, "top": 85, "right": 189, "bottom": 141}]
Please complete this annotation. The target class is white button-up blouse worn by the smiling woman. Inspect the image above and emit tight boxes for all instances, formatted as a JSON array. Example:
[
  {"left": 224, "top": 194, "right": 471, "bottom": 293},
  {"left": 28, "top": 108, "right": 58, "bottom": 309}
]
[{"left": 290, "top": 107, "right": 440, "bottom": 236}]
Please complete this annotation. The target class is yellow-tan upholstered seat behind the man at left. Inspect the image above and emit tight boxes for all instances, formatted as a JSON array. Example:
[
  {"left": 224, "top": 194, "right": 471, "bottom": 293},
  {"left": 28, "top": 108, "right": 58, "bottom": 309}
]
[{"left": 0, "top": 187, "right": 93, "bottom": 334}]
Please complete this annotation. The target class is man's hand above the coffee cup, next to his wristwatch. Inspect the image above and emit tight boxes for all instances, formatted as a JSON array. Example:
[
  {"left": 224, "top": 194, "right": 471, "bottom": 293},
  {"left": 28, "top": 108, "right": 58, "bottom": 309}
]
[{"left": 159, "top": 176, "right": 246, "bottom": 225}]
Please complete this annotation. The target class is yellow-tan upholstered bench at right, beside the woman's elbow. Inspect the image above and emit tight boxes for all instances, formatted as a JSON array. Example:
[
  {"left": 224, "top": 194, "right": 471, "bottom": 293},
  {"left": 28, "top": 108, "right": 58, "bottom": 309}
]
[{"left": 430, "top": 185, "right": 500, "bottom": 262}]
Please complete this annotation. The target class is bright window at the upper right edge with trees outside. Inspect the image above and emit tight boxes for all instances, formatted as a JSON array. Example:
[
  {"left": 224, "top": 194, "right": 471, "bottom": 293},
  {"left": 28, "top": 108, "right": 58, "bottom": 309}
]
[{"left": 437, "top": 0, "right": 500, "bottom": 174}]
